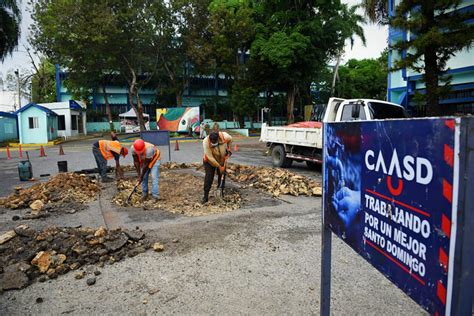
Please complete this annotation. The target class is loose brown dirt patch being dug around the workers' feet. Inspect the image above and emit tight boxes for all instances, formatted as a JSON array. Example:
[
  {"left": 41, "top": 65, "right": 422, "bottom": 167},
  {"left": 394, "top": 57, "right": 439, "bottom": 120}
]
[{"left": 113, "top": 170, "right": 242, "bottom": 216}]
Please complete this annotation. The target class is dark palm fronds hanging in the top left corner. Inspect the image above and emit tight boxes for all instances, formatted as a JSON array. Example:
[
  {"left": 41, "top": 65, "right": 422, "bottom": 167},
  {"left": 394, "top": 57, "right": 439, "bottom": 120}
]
[{"left": 0, "top": 0, "right": 21, "bottom": 62}]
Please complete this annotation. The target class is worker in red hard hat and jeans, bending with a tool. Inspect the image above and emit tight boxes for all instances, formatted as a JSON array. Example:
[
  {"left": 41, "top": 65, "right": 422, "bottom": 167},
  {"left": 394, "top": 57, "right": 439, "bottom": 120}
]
[{"left": 131, "top": 139, "right": 161, "bottom": 201}]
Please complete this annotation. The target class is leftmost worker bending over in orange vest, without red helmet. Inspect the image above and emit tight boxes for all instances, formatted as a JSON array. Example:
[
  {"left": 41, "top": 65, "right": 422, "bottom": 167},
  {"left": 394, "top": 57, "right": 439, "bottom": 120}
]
[{"left": 92, "top": 140, "right": 128, "bottom": 182}]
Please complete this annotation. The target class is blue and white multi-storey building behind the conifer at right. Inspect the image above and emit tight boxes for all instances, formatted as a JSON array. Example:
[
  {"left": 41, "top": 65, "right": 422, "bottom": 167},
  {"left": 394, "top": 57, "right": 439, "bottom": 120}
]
[{"left": 387, "top": 0, "right": 474, "bottom": 113}]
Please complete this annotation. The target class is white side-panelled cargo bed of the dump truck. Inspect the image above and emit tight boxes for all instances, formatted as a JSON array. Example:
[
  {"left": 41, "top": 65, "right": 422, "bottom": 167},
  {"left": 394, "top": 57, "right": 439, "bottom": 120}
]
[{"left": 260, "top": 124, "right": 323, "bottom": 148}]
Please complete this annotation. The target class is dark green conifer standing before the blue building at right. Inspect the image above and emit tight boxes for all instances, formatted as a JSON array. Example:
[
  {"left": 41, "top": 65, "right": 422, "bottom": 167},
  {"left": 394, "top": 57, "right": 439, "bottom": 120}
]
[{"left": 389, "top": 0, "right": 474, "bottom": 116}]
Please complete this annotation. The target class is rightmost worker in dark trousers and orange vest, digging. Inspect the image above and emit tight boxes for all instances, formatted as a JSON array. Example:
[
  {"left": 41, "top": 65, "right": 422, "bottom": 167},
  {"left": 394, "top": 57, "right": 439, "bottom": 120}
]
[{"left": 201, "top": 132, "right": 232, "bottom": 204}]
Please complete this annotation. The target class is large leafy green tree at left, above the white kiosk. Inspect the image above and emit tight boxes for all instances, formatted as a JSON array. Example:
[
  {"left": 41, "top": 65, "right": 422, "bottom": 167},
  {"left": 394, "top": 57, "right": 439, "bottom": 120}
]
[{"left": 33, "top": 0, "right": 165, "bottom": 130}]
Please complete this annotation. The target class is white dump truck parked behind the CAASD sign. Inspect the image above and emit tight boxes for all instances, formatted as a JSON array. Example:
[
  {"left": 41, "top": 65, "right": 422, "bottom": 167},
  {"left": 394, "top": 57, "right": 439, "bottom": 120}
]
[{"left": 260, "top": 98, "right": 407, "bottom": 168}]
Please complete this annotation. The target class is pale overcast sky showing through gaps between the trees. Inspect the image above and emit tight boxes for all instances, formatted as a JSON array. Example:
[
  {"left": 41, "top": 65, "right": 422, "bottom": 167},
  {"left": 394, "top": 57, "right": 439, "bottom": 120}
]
[{"left": 0, "top": 0, "right": 388, "bottom": 82}]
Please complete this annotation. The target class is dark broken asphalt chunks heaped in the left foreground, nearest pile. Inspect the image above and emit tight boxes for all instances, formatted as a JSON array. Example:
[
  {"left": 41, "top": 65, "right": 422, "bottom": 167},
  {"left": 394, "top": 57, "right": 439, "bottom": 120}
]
[{"left": 0, "top": 225, "right": 151, "bottom": 290}]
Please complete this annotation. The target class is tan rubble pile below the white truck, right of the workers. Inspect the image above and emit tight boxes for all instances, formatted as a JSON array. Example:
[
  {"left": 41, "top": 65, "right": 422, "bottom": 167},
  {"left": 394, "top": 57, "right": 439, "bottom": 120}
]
[{"left": 227, "top": 164, "right": 322, "bottom": 197}]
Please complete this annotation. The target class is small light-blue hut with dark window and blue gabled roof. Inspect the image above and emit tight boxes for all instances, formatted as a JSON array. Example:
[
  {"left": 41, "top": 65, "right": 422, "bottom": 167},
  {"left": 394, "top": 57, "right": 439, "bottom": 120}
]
[{"left": 15, "top": 103, "right": 58, "bottom": 144}]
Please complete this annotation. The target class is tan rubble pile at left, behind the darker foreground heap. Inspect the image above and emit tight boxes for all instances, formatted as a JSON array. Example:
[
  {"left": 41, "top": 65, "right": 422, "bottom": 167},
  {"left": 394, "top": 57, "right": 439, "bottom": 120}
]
[{"left": 0, "top": 173, "right": 100, "bottom": 213}]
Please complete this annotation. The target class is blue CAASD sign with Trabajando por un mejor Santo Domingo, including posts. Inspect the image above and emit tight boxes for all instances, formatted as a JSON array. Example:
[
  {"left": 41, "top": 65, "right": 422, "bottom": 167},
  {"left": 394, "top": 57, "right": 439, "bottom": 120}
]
[{"left": 320, "top": 117, "right": 474, "bottom": 315}]
